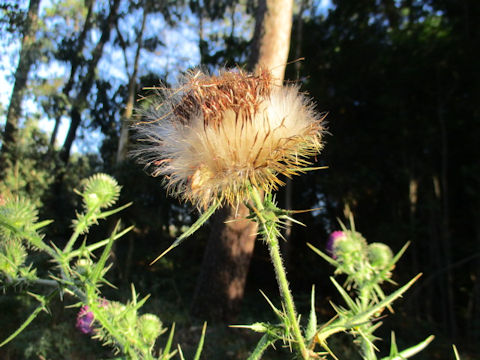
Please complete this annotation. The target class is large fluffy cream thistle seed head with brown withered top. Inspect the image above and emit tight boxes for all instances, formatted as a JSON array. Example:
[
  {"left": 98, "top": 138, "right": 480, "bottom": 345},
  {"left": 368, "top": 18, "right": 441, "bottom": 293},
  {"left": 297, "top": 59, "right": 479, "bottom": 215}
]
[{"left": 132, "top": 70, "right": 324, "bottom": 208}]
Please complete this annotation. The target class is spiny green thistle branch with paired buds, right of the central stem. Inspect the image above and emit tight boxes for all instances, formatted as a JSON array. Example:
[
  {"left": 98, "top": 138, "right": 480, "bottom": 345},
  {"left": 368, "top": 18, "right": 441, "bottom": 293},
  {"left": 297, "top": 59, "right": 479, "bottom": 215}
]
[{"left": 308, "top": 218, "right": 433, "bottom": 360}]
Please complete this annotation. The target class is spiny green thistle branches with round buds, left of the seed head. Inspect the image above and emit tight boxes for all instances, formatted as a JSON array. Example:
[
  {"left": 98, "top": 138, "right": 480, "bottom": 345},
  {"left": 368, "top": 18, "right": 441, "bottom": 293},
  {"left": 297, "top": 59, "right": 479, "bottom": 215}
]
[{"left": 0, "top": 174, "right": 205, "bottom": 360}]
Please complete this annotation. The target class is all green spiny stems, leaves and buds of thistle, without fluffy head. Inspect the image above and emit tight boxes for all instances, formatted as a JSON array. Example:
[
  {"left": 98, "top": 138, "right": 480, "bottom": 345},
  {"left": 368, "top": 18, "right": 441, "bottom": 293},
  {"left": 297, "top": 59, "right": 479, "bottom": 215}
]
[{"left": 0, "top": 169, "right": 433, "bottom": 360}]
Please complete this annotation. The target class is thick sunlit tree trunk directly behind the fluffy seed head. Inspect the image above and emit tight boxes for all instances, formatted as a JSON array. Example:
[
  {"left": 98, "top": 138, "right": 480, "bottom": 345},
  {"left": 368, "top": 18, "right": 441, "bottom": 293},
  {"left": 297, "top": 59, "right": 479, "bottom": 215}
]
[{"left": 191, "top": 0, "right": 293, "bottom": 322}]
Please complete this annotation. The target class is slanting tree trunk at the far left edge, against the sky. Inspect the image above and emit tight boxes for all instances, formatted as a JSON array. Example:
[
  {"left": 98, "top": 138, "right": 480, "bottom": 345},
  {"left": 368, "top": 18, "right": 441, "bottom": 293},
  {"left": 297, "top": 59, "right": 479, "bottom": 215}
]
[{"left": 0, "top": 0, "right": 40, "bottom": 176}]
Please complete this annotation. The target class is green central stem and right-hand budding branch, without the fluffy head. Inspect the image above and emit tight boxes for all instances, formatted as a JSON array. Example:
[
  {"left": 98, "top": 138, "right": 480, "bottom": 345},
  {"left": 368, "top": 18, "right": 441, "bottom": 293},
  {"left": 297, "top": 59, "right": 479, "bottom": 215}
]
[{"left": 242, "top": 189, "right": 433, "bottom": 360}]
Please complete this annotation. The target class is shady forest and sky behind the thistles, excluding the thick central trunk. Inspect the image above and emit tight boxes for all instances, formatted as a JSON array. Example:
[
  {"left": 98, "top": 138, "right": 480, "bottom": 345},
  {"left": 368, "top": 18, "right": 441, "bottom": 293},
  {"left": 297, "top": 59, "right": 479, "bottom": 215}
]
[{"left": 0, "top": 0, "right": 480, "bottom": 359}]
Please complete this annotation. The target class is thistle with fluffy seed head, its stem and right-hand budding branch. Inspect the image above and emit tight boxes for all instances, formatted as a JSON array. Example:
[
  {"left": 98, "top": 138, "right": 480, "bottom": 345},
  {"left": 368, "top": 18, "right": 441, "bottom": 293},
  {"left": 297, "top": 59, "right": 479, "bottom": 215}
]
[{"left": 132, "top": 69, "right": 431, "bottom": 360}]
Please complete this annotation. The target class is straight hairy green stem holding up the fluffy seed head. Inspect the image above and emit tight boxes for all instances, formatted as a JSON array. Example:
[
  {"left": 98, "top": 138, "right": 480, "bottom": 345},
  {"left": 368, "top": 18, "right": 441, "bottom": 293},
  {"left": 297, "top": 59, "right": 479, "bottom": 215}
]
[{"left": 246, "top": 187, "right": 310, "bottom": 360}]
